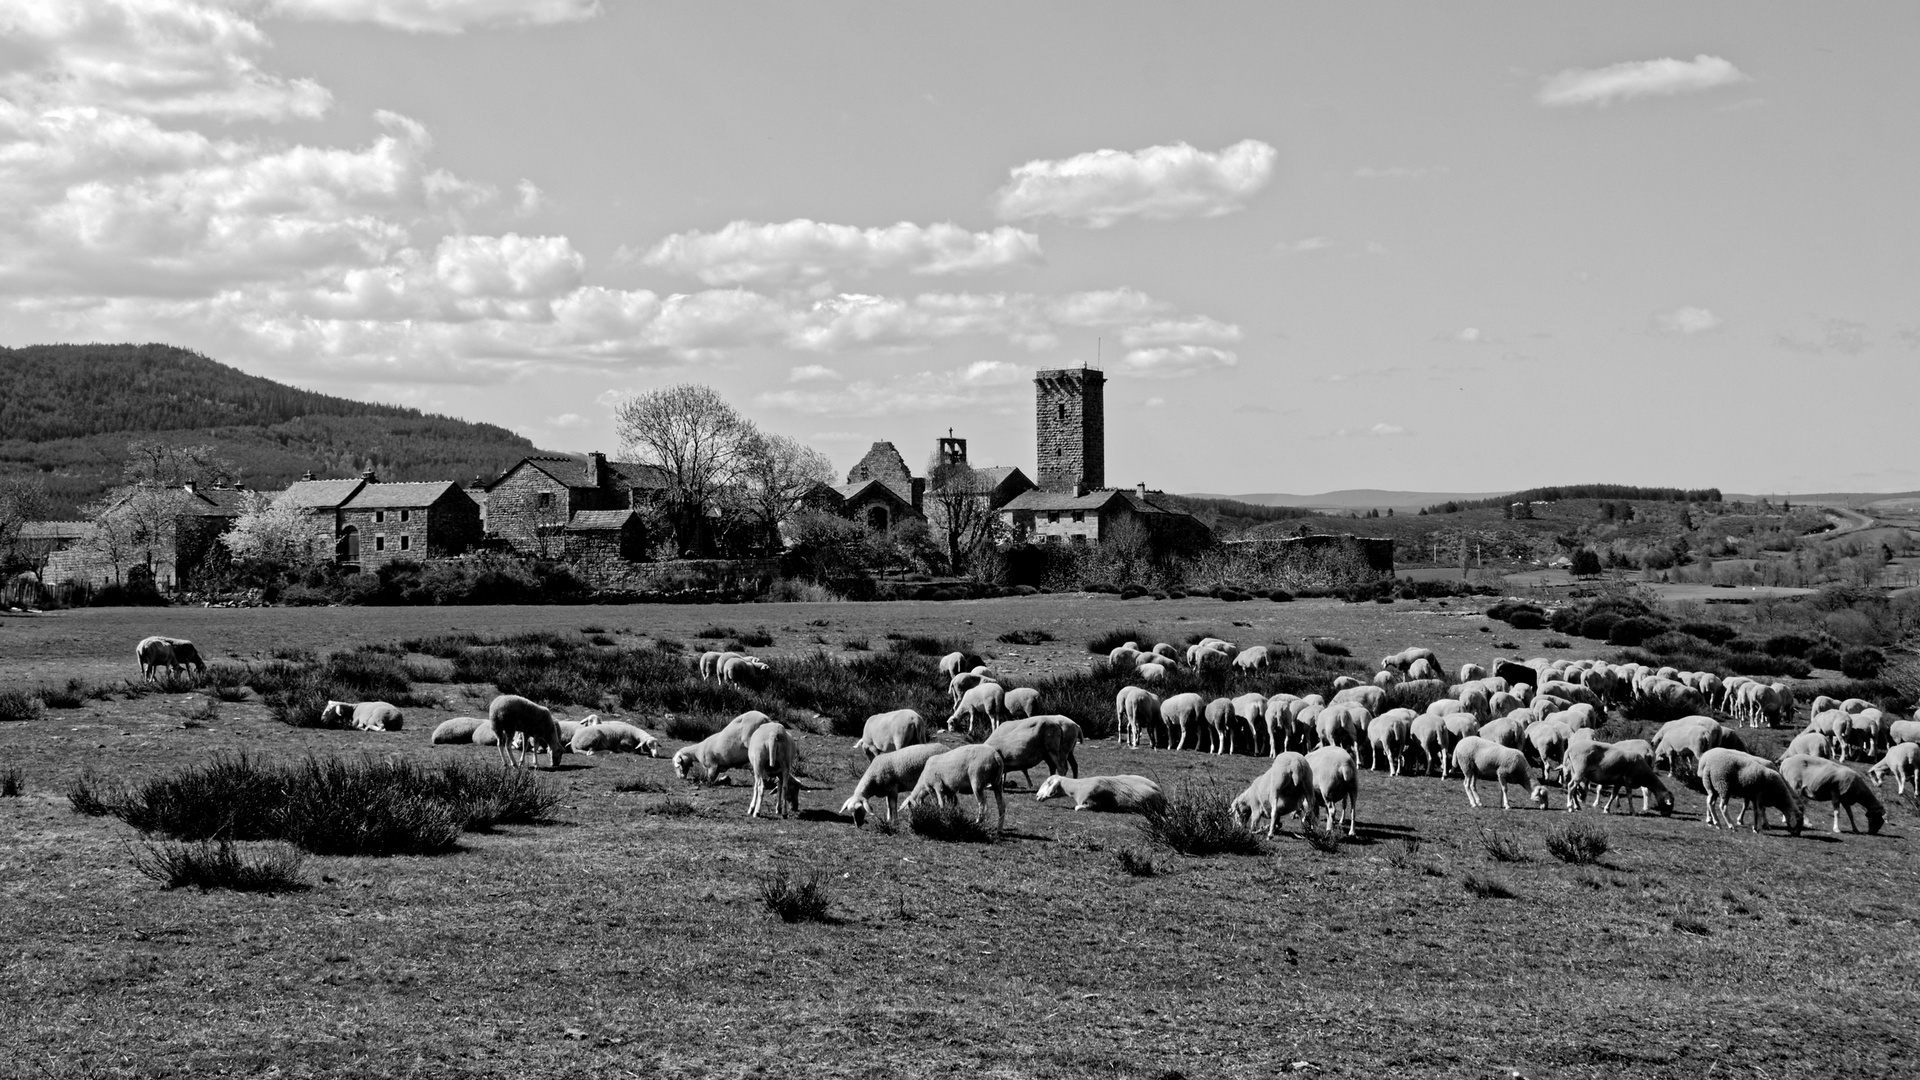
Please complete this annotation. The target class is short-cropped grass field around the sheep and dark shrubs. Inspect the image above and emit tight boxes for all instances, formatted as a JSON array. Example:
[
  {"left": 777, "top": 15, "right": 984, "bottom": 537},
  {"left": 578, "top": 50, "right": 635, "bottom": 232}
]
[{"left": 0, "top": 596, "right": 1920, "bottom": 1078}]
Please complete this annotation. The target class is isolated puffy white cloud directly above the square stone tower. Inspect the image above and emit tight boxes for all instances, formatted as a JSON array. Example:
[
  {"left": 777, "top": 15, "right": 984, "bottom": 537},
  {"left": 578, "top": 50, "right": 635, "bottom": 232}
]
[{"left": 995, "top": 138, "right": 1277, "bottom": 229}]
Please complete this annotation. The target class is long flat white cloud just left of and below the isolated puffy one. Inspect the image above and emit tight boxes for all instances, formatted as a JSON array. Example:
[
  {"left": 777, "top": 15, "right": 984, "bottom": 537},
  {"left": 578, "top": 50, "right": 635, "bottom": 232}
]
[{"left": 639, "top": 217, "right": 1041, "bottom": 284}]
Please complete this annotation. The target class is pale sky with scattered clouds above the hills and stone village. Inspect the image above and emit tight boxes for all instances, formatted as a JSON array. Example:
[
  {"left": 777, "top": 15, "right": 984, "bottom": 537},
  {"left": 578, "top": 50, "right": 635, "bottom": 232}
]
[{"left": 0, "top": 0, "right": 1920, "bottom": 494}]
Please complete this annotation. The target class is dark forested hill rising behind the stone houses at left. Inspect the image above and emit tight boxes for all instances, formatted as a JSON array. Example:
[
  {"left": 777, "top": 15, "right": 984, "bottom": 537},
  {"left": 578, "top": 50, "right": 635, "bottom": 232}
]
[{"left": 0, "top": 344, "right": 549, "bottom": 517}]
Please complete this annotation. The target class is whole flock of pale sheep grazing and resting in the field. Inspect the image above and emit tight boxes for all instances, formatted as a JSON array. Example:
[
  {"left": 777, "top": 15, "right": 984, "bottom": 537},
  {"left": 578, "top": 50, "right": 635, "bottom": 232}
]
[{"left": 138, "top": 638, "right": 1920, "bottom": 836}]
